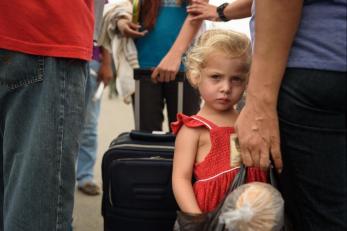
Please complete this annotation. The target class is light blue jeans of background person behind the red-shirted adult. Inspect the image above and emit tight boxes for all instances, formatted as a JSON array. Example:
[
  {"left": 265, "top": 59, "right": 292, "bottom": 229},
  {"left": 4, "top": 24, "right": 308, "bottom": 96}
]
[{"left": 77, "top": 60, "right": 100, "bottom": 186}]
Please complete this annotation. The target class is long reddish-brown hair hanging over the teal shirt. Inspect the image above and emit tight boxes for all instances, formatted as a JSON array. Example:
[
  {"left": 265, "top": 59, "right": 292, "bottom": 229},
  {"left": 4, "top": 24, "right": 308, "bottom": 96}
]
[{"left": 141, "top": 0, "right": 184, "bottom": 30}]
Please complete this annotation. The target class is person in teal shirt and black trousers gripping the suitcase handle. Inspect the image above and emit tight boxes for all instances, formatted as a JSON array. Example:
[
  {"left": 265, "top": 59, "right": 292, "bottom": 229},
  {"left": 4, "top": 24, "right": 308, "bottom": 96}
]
[{"left": 103, "top": 0, "right": 208, "bottom": 131}]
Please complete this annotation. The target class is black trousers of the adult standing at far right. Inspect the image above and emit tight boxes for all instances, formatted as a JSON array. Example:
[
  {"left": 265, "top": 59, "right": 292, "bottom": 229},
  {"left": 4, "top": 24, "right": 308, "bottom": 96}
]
[{"left": 278, "top": 69, "right": 347, "bottom": 231}]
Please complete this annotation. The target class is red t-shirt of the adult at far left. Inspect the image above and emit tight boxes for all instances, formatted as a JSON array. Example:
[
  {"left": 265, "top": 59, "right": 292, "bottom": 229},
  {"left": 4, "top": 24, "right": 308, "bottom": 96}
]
[{"left": 0, "top": 0, "right": 94, "bottom": 60}]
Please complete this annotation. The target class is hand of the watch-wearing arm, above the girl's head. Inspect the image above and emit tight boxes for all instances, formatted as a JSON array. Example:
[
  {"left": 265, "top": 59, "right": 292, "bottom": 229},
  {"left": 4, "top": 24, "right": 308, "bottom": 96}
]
[{"left": 187, "top": 0, "right": 219, "bottom": 21}]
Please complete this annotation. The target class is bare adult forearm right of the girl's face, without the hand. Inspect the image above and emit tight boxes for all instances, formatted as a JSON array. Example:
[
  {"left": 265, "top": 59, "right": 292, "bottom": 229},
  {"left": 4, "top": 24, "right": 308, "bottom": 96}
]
[{"left": 247, "top": 0, "right": 303, "bottom": 107}]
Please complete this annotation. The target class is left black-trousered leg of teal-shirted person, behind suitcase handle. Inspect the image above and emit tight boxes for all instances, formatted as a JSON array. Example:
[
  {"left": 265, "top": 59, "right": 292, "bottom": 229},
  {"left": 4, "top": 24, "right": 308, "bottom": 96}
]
[{"left": 133, "top": 79, "right": 164, "bottom": 132}]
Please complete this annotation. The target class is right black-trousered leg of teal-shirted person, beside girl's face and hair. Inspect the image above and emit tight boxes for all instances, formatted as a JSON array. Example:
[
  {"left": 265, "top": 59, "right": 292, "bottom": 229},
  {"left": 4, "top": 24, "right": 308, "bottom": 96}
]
[{"left": 164, "top": 80, "right": 201, "bottom": 131}]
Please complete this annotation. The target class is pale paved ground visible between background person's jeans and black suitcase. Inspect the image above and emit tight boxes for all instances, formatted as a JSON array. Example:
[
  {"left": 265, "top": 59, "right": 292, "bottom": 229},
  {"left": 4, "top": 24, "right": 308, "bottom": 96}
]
[{"left": 73, "top": 88, "right": 167, "bottom": 231}]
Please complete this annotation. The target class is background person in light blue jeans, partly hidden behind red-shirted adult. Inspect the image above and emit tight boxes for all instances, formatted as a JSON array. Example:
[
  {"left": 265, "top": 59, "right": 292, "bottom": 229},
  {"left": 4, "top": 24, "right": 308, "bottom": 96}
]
[{"left": 76, "top": 0, "right": 113, "bottom": 196}]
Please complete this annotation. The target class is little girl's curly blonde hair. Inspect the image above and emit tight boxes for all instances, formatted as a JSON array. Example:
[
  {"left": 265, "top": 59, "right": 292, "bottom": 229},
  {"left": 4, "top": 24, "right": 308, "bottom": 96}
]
[{"left": 184, "top": 29, "right": 252, "bottom": 87}]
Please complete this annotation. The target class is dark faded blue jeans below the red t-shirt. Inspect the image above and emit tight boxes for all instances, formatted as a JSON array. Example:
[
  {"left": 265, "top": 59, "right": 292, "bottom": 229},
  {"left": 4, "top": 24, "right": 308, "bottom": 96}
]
[{"left": 0, "top": 49, "right": 88, "bottom": 231}]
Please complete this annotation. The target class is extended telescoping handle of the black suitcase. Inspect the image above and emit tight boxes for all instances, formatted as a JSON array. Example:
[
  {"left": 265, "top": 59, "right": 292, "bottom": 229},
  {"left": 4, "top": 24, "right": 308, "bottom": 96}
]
[{"left": 134, "top": 68, "right": 184, "bottom": 131}]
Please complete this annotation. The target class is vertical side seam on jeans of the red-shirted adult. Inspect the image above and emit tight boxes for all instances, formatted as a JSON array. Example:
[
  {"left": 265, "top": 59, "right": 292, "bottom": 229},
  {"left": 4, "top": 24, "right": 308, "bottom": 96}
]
[{"left": 56, "top": 61, "right": 66, "bottom": 230}]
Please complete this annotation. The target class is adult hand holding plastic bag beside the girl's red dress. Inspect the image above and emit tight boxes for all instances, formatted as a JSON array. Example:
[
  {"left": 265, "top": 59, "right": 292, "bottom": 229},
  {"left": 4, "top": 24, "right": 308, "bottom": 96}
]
[{"left": 235, "top": 95, "right": 282, "bottom": 172}]
